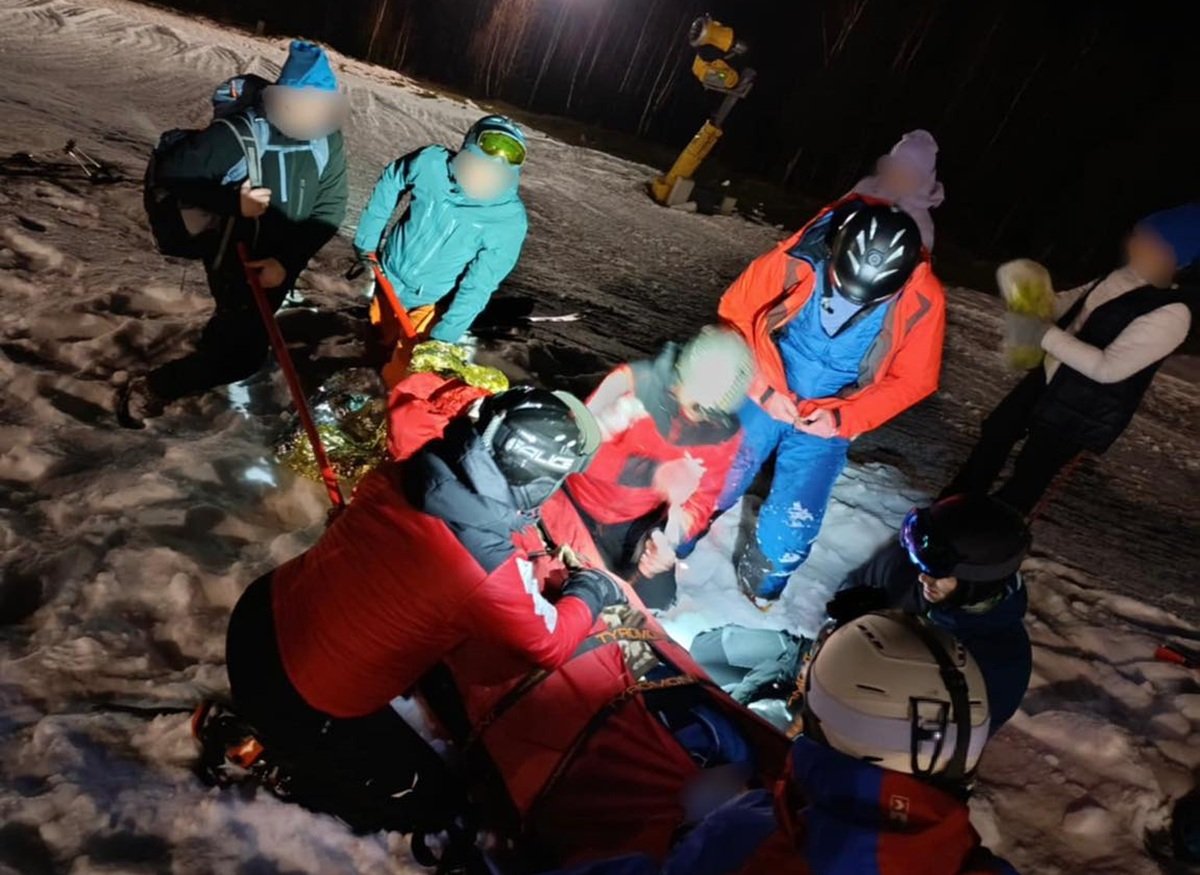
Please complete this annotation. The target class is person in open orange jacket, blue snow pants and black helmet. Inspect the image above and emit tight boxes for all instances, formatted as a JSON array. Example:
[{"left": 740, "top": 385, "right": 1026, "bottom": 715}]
[{"left": 719, "top": 196, "right": 946, "bottom": 601}]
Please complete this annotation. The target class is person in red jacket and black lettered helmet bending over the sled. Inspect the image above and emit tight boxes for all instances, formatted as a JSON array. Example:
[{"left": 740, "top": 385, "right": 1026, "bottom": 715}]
[{"left": 218, "top": 388, "right": 624, "bottom": 832}]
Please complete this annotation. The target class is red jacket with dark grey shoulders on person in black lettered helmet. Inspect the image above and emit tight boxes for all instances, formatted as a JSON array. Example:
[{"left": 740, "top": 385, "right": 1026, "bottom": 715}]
[{"left": 271, "top": 420, "right": 599, "bottom": 717}]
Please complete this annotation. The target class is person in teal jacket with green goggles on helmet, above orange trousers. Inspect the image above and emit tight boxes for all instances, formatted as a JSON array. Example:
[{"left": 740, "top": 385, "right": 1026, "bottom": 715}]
[{"left": 354, "top": 115, "right": 528, "bottom": 343}]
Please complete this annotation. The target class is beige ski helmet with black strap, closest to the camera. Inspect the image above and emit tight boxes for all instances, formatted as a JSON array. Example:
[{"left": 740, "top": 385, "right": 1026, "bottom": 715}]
[{"left": 804, "top": 611, "right": 988, "bottom": 784}]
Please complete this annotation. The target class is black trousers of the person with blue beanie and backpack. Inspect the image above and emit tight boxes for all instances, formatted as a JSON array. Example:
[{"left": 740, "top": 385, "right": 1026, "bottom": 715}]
[{"left": 146, "top": 248, "right": 295, "bottom": 401}]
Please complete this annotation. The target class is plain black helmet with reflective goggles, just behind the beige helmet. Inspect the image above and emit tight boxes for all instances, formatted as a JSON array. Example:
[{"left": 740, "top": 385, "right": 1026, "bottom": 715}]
[{"left": 900, "top": 496, "right": 1031, "bottom": 583}]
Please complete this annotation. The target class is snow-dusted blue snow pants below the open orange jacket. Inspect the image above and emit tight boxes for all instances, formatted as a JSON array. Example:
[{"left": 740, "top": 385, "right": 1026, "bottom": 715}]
[{"left": 718, "top": 402, "right": 850, "bottom": 599}]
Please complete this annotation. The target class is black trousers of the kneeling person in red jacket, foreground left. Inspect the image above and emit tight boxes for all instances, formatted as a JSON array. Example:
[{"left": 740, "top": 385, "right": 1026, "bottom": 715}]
[{"left": 226, "top": 575, "right": 464, "bottom": 832}]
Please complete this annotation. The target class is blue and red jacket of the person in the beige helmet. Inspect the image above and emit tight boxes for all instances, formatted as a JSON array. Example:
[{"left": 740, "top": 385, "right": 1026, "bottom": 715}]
[{"left": 791, "top": 737, "right": 1003, "bottom": 875}]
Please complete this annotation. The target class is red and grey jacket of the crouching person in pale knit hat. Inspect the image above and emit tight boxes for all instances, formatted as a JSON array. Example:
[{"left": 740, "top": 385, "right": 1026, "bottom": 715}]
[{"left": 566, "top": 343, "right": 742, "bottom": 541}]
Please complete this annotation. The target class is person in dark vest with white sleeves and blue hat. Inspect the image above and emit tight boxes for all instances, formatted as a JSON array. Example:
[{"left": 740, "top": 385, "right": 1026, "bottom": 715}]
[{"left": 943, "top": 202, "right": 1200, "bottom": 514}]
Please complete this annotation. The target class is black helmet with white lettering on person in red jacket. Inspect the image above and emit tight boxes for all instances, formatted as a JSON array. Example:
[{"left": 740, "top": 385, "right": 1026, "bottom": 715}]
[{"left": 475, "top": 386, "right": 600, "bottom": 510}]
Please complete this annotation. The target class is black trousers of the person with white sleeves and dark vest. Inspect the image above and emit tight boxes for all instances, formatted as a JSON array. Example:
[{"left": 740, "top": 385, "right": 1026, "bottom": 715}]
[{"left": 942, "top": 367, "right": 1084, "bottom": 515}]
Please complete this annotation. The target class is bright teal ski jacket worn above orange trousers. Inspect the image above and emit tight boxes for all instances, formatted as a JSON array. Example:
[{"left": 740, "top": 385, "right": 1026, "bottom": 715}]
[{"left": 354, "top": 145, "right": 528, "bottom": 343}]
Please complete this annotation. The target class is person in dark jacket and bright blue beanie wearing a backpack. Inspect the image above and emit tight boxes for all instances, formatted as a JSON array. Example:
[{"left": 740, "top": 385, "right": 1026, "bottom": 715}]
[{"left": 118, "top": 40, "right": 348, "bottom": 428}]
